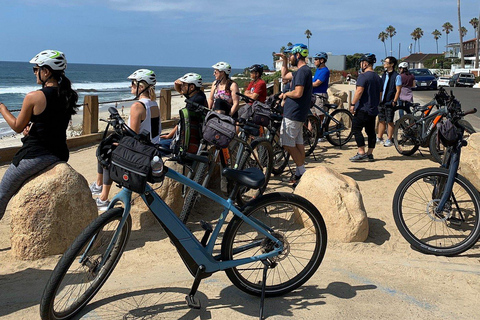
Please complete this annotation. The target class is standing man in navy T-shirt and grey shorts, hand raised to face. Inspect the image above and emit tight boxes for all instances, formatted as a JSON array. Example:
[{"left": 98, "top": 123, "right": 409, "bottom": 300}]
[{"left": 276, "top": 44, "right": 312, "bottom": 187}]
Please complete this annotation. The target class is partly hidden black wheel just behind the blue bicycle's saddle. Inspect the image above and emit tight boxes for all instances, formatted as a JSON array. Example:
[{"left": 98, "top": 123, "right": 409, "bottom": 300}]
[{"left": 236, "top": 138, "right": 273, "bottom": 206}]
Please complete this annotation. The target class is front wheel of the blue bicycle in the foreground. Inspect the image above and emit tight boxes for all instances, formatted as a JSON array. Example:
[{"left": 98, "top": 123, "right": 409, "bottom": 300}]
[{"left": 40, "top": 208, "right": 132, "bottom": 320}]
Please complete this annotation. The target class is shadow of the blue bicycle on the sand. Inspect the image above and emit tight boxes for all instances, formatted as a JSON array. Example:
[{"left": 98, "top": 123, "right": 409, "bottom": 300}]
[{"left": 74, "top": 280, "right": 377, "bottom": 320}]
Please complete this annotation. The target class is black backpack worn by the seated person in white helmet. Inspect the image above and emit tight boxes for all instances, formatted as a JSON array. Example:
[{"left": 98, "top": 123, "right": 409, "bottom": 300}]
[{"left": 171, "top": 108, "right": 204, "bottom": 154}]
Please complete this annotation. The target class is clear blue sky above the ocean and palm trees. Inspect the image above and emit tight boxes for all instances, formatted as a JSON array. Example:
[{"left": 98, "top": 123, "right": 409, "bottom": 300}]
[{"left": 0, "top": 0, "right": 480, "bottom": 68}]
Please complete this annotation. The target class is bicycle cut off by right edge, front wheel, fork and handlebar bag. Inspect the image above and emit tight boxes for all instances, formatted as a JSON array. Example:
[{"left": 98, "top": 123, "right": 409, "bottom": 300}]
[{"left": 393, "top": 99, "right": 480, "bottom": 256}]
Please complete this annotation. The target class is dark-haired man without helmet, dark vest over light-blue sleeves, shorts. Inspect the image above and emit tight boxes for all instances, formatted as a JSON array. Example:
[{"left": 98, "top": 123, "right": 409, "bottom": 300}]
[{"left": 376, "top": 56, "right": 402, "bottom": 147}]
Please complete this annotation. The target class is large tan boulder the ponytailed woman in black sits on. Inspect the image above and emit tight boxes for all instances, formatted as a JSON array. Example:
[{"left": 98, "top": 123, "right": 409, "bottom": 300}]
[{"left": 10, "top": 162, "right": 98, "bottom": 260}]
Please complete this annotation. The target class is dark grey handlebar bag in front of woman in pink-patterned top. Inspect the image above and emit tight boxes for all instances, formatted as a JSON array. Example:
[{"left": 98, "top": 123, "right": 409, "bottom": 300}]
[{"left": 203, "top": 111, "right": 236, "bottom": 148}]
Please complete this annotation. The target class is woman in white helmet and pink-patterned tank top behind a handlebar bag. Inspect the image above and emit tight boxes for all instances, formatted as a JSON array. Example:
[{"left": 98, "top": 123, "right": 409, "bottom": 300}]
[{"left": 208, "top": 62, "right": 239, "bottom": 118}]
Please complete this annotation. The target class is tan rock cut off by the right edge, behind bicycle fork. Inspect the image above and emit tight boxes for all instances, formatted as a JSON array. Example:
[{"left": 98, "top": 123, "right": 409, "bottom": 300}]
[{"left": 458, "top": 133, "right": 480, "bottom": 190}]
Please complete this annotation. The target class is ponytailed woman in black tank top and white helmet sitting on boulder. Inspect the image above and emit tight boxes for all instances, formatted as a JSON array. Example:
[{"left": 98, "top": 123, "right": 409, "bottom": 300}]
[{"left": 0, "top": 50, "right": 78, "bottom": 219}]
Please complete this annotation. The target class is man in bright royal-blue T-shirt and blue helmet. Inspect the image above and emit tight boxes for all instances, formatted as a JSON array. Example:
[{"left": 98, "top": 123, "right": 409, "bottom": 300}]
[{"left": 312, "top": 52, "right": 330, "bottom": 120}]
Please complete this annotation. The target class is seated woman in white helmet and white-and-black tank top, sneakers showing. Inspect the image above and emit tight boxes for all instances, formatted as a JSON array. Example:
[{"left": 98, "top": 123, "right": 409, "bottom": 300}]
[{"left": 90, "top": 69, "right": 162, "bottom": 211}]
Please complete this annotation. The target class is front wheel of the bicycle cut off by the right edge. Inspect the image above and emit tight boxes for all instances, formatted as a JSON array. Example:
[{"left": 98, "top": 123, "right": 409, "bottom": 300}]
[{"left": 393, "top": 168, "right": 480, "bottom": 256}]
